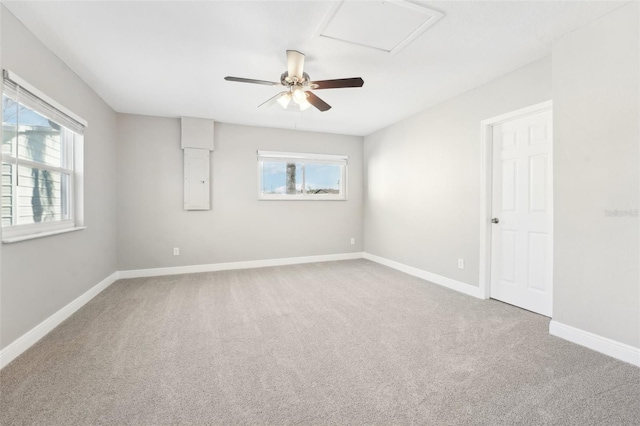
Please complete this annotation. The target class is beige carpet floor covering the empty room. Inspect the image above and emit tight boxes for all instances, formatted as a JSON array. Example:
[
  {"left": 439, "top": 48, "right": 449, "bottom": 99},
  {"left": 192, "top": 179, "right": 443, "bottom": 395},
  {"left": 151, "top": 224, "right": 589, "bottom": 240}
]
[{"left": 0, "top": 260, "right": 640, "bottom": 425}]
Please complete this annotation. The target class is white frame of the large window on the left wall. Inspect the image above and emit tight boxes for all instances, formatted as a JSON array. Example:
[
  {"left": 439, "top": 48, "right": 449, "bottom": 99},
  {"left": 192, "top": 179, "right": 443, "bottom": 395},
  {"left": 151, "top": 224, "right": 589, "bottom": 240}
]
[{"left": 2, "top": 70, "right": 87, "bottom": 243}]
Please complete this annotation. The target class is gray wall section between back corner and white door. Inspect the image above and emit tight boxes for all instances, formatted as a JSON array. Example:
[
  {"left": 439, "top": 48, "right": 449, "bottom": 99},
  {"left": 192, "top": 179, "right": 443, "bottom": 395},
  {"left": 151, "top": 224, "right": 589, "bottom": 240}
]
[{"left": 364, "top": 58, "right": 551, "bottom": 286}]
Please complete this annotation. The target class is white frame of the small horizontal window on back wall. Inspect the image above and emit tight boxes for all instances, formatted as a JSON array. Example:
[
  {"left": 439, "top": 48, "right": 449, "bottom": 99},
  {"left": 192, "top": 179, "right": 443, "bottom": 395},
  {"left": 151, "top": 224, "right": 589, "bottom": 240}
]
[{"left": 257, "top": 151, "right": 349, "bottom": 201}]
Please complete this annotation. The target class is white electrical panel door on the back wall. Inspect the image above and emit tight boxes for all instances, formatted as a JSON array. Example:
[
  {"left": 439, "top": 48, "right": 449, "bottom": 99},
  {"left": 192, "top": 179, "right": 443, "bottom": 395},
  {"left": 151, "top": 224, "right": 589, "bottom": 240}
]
[{"left": 184, "top": 148, "right": 211, "bottom": 210}]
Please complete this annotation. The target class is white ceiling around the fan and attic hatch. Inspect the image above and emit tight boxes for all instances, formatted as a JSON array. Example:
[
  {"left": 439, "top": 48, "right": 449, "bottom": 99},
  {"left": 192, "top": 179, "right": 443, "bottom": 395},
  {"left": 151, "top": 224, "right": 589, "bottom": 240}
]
[{"left": 3, "top": 1, "right": 627, "bottom": 135}]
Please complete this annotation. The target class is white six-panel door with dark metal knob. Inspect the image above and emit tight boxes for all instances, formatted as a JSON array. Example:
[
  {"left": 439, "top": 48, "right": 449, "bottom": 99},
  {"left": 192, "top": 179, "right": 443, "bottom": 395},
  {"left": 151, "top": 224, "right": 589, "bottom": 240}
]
[{"left": 491, "top": 111, "right": 553, "bottom": 317}]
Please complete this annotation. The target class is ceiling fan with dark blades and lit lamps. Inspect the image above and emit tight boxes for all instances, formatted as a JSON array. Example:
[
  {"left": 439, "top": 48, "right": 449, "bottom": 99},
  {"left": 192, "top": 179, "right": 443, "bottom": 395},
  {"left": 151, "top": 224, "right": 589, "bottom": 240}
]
[{"left": 224, "top": 50, "right": 364, "bottom": 112}]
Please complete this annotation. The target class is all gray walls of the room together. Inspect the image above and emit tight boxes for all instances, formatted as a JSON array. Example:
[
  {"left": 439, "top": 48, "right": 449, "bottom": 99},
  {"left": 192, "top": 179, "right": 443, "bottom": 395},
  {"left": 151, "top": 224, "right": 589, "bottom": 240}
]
[{"left": 0, "top": 3, "right": 640, "bottom": 356}]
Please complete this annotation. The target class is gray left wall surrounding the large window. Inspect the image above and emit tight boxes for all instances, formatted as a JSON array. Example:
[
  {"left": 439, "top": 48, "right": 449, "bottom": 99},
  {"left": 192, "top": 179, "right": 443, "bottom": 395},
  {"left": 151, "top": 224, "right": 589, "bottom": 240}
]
[{"left": 0, "top": 8, "right": 117, "bottom": 348}]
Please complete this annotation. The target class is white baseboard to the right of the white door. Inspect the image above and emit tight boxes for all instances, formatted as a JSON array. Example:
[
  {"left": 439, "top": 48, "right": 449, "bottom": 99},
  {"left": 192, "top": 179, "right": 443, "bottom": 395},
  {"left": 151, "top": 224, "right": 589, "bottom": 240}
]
[{"left": 549, "top": 320, "right": 640, "bottom": 367}]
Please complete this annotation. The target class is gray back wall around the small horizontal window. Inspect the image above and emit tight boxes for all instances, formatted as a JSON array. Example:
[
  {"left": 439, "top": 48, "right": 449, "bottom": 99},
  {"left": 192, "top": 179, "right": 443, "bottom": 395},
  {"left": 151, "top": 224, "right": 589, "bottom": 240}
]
[{"left": 118, "top": 114, "right": 363, "bottom": 270}]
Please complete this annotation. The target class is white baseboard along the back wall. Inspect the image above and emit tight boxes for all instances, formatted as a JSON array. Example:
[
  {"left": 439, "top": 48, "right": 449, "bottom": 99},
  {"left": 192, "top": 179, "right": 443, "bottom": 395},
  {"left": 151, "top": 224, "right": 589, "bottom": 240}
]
[{"left": 119, "top": 252, "right": 363, "bottom": 278}]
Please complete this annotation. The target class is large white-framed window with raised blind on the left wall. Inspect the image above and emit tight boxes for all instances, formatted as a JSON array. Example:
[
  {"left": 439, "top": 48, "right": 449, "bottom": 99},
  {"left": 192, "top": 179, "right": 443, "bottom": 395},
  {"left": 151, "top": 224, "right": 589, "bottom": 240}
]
[{"left": 2, "top": 70, "right": 86, "bottom": 242}]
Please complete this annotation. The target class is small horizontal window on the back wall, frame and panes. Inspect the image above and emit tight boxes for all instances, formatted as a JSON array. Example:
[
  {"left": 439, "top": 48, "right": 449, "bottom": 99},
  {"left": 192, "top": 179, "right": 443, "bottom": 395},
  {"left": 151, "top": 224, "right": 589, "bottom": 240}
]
[{"left": 258, "top": 151, "right": 348, "bottom": 200}]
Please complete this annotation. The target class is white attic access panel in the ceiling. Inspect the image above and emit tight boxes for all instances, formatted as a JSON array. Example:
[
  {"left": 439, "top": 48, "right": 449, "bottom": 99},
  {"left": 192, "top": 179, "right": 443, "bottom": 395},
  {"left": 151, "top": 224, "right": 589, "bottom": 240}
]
[{"left": 316, "top": 0, "right": 444, "bottom": 55}]
